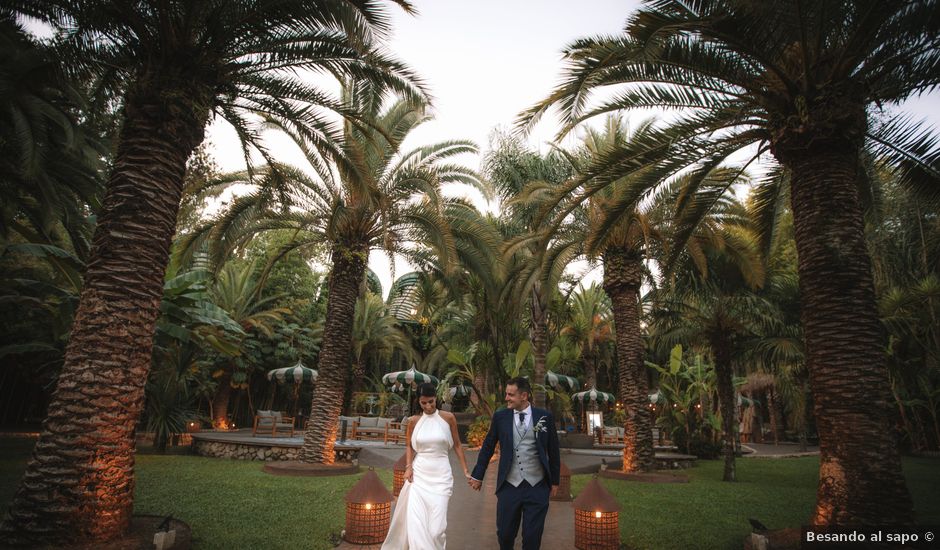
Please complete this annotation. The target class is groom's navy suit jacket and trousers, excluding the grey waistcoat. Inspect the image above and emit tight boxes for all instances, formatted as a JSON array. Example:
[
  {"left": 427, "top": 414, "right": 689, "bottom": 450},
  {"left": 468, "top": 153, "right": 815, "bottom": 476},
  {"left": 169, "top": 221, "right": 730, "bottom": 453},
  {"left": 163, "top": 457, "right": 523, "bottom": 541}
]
[{"left": 472, "top": 407, "right": 561, "bottom": 550}]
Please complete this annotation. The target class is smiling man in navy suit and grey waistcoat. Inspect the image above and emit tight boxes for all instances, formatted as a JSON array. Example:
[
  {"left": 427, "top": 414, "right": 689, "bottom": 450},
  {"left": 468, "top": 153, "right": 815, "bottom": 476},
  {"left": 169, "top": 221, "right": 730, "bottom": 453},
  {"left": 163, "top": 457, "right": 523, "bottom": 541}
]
[{"left": 469, "top": 377, "right": 561, "bottom": 550}]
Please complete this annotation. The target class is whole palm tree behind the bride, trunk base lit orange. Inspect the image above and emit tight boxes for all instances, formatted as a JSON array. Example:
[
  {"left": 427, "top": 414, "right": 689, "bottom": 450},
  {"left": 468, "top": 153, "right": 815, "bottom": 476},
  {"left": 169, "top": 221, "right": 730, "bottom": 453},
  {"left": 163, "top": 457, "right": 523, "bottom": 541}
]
[{"left": 185, "top": 81, "right": 480, "bottom": 464}]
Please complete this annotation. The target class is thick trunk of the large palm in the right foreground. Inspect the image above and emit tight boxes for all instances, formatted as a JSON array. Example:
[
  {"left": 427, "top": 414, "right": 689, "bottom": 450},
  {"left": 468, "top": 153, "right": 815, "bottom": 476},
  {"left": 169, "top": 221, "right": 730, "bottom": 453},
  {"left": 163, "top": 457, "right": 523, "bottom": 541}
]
[{"left": 775, "top": 139, "right": 913, "bottom": 525}]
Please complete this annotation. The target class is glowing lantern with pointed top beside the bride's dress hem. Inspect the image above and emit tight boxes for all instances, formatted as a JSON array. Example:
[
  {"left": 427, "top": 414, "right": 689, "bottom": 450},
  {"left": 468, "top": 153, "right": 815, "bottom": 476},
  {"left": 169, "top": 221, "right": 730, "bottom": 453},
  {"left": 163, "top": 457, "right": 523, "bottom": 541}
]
[{"left": 343, "top": 468, "right": 392, "bottom": 544}]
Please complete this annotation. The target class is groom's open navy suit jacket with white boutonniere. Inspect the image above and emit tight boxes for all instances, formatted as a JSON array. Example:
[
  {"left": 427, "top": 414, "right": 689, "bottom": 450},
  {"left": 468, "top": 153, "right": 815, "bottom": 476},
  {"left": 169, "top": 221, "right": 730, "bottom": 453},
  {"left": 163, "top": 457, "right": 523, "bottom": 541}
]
[{"left": 472, "top": 407, "right": 561, "bottom": 491}]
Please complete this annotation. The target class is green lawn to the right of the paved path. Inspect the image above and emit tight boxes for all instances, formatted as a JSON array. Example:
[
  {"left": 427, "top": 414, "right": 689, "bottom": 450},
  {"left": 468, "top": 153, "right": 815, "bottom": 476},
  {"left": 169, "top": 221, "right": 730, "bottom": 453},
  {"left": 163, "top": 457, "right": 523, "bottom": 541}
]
[{"left": 571, "top": 457, "right": 940, "bottom": 550}]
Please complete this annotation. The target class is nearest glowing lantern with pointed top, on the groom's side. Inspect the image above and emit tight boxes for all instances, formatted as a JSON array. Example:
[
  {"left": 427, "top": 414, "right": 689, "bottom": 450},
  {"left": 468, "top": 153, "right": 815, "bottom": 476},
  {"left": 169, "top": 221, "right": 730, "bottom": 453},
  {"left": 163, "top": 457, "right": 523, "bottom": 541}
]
[{"left": 574, "top": 476, "right": 620, "bottom": 550}]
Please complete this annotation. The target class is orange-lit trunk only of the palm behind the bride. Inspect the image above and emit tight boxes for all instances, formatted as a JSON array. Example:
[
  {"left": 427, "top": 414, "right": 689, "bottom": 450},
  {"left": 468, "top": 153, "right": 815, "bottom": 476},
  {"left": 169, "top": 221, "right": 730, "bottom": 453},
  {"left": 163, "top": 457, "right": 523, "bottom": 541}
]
[{"left": 300, "top": 244, "right": 369, "bottom": 464}]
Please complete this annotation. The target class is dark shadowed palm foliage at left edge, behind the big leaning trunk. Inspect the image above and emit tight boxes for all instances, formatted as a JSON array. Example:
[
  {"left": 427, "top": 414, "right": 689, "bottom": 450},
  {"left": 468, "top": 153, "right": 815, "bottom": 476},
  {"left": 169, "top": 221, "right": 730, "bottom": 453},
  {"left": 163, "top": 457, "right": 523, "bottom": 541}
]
[{"left": 0, "top": 11, "right": 106, "bottom": 252}]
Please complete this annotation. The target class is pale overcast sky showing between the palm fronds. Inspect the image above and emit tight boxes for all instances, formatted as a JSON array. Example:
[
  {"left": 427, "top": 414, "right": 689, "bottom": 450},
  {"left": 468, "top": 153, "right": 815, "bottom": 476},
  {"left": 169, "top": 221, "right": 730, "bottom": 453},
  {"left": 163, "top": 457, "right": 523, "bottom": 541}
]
[{"left": 209, "top": 0, "right": 940, "bottom": 293}]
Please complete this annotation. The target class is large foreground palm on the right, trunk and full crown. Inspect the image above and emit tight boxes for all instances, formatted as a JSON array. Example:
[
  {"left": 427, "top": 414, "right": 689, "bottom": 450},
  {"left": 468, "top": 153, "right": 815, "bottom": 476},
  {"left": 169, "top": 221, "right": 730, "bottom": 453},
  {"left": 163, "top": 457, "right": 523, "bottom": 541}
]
[{"left": 524, "top": 0, "right": 940, "bottom": 524}]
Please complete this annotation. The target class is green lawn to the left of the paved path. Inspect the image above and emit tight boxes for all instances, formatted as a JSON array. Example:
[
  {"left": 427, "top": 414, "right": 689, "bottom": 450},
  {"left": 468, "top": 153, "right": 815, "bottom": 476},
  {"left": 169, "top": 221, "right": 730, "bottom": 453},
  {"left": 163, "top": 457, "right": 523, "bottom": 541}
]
[{"left": 0, "top": 438, "right": 392, "bottom": 550}]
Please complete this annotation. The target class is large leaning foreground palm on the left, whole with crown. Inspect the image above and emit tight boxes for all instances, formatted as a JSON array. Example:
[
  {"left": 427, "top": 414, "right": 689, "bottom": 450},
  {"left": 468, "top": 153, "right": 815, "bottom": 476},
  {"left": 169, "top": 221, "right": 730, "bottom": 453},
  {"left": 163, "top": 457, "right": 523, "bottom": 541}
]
[{"left": 2, "top": 0, "right": 420, "bottom": 544}]
